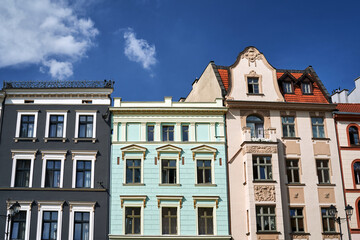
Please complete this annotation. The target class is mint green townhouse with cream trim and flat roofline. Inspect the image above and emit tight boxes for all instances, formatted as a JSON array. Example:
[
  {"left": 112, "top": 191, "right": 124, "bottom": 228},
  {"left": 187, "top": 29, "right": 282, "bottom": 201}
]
[{"left": 109, "top": 97, "right": 230, "bottom": 239}]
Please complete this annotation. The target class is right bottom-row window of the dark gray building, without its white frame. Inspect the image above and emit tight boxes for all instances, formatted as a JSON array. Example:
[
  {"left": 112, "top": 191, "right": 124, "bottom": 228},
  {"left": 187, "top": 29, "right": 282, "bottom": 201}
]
[{"left": 73, "top": 212, "right": 90, "bottom": 240}]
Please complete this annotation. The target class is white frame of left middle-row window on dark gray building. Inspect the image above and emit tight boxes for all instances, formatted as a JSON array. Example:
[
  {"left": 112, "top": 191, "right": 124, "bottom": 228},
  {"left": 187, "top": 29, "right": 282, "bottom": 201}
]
[{"left": 10, "top": 150, "right": 37, "bottom": 188}]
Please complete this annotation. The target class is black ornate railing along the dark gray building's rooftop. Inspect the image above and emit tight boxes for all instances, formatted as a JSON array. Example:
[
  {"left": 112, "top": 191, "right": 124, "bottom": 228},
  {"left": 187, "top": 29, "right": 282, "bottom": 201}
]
[{"left": 3, "top": 80, "right": 115, "bottom": 89}]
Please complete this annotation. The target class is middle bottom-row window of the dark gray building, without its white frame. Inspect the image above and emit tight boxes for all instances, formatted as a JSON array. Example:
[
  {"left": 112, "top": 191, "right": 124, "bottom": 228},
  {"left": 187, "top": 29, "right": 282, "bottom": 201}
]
[{"left": 41, "top": 211, "right": 58, "bottom": 240}]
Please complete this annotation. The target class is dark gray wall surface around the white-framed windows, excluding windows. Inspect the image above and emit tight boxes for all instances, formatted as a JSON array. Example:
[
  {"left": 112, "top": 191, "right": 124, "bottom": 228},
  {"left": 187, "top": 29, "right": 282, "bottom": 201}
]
[{"left": 0, "top": 104, "right": 111, "bottom": 240}]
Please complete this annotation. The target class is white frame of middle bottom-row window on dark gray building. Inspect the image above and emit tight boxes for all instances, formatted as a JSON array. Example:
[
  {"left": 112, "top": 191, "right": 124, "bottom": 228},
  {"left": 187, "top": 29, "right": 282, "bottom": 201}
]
[{"left": 36, "top": 201, "right": 63, "bottom": 240}]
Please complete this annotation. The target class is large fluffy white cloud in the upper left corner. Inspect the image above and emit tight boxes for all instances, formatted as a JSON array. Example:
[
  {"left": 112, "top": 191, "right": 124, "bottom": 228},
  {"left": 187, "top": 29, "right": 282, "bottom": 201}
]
[{"left": 0, "top": 0, "right": 99, "bottom": 78}]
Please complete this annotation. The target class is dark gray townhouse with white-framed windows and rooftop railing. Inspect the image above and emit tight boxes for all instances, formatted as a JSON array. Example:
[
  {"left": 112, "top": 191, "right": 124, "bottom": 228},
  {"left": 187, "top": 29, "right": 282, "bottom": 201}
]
[{"left": 0, "top": 81, "right": 113, "bottom": 240}]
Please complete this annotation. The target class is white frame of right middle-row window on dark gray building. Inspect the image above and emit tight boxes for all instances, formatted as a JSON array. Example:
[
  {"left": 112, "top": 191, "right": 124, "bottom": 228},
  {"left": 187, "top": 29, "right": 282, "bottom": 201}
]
[{"left": 71, "top": 150, "right": 97, "bottom": 188}]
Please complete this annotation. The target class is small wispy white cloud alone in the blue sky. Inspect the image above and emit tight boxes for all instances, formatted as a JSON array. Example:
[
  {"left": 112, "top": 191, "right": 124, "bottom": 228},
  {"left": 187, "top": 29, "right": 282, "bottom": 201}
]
[{"left": 124, "top": 28, "right": 157, "bottom": 70}]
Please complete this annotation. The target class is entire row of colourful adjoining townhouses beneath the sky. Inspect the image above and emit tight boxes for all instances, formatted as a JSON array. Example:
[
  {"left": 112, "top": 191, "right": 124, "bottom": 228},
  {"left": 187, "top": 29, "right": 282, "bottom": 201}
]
[{"left": 0, "top": 47, "right": 360, "bottom": 240}]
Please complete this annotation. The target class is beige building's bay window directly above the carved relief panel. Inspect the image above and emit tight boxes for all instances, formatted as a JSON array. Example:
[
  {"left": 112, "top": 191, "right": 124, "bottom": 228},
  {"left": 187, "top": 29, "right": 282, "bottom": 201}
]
[{"left": 253, "top": 156, "right": 272, "bottom": 181}]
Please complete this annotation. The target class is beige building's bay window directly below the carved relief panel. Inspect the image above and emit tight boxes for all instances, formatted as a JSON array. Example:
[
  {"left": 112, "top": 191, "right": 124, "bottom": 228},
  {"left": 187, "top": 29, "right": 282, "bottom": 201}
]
[{"left": 256, "top": 206, "right": 276, "bottom": 232}]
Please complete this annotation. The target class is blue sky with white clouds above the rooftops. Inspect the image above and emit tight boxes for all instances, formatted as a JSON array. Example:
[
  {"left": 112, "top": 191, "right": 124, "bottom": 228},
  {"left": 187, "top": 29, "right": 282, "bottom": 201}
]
[{"left": 0, "top": 0, "right": 360, "bottom": 101}]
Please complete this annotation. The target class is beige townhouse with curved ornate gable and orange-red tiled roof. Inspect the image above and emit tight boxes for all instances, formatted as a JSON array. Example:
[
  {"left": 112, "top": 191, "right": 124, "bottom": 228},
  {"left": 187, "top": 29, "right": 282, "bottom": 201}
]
[{"left": 185, "top": 47, "right": 348, "bottom": 240}]
